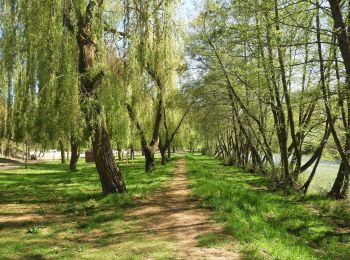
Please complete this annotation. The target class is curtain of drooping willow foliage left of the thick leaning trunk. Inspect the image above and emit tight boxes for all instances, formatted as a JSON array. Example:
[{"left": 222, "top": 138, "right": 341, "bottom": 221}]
[{"left": 1, "top": 1, "right": 79, "bottom": 165}]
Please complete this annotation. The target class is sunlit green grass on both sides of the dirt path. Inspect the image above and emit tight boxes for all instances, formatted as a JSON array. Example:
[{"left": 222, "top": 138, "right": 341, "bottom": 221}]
[{"left": 0, "top": 155, "right": 350, "bottom": 259}]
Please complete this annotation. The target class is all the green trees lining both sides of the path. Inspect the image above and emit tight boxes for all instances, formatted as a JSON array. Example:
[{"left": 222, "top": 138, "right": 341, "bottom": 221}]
[{"left": 0, "top": 0, "right": 350, "bottom": 199}]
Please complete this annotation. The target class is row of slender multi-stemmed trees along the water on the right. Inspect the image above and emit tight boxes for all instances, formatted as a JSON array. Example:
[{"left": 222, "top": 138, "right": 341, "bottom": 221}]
[{"left": 187, "top": 0, "right": 350, "bottom": 198}]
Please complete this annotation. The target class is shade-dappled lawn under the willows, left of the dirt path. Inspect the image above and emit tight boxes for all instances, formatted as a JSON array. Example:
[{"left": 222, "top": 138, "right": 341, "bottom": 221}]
[{"left": 0, "top": 155, "right": 176, "bottom": 259}]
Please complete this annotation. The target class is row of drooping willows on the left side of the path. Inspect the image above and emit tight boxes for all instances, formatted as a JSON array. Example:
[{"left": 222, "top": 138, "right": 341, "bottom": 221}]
[{"left": 0, "top": 0, "right": 188, "bottom": 194}]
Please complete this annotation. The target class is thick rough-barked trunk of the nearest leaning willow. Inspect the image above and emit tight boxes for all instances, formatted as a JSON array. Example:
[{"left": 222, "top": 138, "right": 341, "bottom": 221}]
[{"left": 76, "top": 0, "right": 126, "bottom": 195}]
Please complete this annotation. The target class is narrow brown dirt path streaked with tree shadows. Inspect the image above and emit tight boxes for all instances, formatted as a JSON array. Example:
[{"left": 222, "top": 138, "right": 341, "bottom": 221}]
[{"left": 128, "top": 159, "right": 240, "bottom": 259}]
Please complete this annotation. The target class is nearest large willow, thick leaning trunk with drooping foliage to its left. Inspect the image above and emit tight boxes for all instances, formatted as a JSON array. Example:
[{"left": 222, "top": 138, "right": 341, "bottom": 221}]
[{"left": 2, "top": 0, "right": 126, "bottom": 194}]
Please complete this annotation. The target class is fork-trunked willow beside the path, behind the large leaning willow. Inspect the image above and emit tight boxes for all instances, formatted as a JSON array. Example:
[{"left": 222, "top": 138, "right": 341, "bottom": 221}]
[{"left": 127, "top": 0, "right": 179, "bottom": 172}]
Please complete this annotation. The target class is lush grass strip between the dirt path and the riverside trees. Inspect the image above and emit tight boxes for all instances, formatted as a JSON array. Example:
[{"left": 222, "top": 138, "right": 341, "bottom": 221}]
[{"left": 187, "top": 155, "right": 350, "bottom": 259}]
